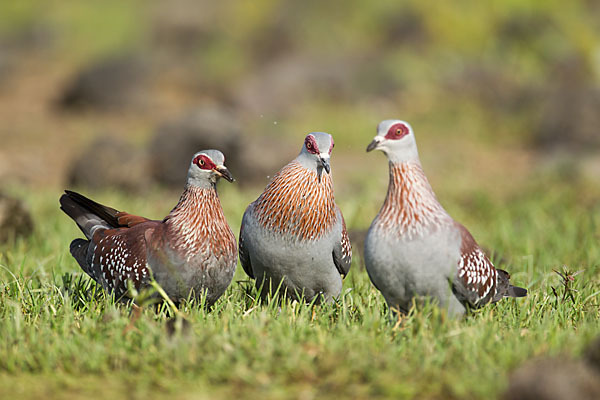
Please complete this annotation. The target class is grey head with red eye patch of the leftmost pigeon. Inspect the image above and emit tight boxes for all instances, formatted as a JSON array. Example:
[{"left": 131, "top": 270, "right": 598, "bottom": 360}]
[{"left": 187, "top": 150, "right": 234, "bottom": 188}]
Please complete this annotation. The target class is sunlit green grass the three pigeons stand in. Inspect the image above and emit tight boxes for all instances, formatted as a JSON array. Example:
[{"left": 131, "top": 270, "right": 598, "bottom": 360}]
[{"left": 0, "top": 181, "right": 600, "bottom": 399}]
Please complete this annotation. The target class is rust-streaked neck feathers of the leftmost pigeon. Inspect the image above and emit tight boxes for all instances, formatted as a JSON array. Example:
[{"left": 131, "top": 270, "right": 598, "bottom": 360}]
[{"left": 165, "top": 186, "right": 236, "bottom": 261}]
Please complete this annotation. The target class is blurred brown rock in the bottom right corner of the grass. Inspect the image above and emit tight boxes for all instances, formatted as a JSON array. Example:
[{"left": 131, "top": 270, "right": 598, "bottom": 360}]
[{"left": 502, "top": 358, "right": 600, "bottom": 400}]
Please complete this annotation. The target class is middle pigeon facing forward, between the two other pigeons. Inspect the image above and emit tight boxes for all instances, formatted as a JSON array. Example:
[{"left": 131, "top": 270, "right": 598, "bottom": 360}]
[{"left": 240, "top": 132, "right": 352, "bottom": 301}]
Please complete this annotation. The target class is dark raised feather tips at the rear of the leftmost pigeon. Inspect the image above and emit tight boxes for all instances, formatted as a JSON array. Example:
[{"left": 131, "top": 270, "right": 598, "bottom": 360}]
[{"left": 60, "top": 190, "right": 119, "bottom": 239}]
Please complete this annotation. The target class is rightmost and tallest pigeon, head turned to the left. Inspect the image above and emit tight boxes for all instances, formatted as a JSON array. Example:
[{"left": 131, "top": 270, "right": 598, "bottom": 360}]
[{"left": 365, "top": 120, "right": 527, "bottom": 315}]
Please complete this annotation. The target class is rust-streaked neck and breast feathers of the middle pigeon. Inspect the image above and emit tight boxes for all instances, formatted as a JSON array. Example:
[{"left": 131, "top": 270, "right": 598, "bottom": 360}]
[{"left": 254, "top": 161, "right": 337, "bottom": 240}]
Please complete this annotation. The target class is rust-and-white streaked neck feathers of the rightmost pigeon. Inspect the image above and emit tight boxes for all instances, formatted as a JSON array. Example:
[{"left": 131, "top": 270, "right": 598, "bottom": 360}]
[{"left": 377, "top": 162, "right": 453, "bottom": 239}]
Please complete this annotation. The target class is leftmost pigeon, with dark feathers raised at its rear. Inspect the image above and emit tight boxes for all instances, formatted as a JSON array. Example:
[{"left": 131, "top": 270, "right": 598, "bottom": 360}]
[{"left": 60, "top": 150, "right": 237, "bottom": 305}]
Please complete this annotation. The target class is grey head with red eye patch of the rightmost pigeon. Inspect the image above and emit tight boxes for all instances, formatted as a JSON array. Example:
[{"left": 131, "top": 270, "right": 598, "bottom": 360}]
[{"left": 367, "top": 119, "right": 419, "bottom": 163}]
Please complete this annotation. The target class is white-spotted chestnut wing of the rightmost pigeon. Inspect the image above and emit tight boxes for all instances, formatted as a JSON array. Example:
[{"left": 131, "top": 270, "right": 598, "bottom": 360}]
[{"left": 453, "top": 225, "right": 498, "bottom": 308}]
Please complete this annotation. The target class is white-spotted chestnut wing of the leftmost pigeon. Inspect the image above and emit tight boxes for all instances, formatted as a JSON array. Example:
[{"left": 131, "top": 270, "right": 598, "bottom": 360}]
[{"left": 89, "top": 221, "right": 158, "bottom": 297}]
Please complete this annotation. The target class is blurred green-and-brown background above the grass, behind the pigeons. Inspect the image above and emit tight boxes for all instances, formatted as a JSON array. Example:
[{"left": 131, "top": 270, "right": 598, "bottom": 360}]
[{"left": 0, "top": 0, "right": 600, "bottom": 201}]
